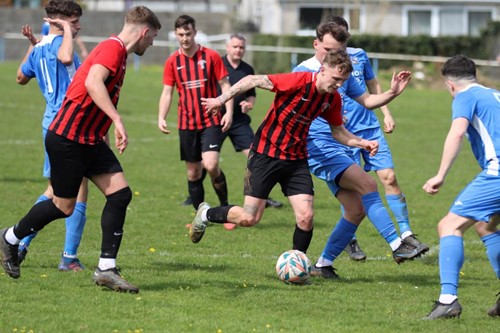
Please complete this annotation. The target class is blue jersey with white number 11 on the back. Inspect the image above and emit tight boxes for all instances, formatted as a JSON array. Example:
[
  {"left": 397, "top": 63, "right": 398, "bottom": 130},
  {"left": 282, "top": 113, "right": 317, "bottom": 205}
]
[{"left": 21, "top": 35, "right": 80, "bottom": 129}]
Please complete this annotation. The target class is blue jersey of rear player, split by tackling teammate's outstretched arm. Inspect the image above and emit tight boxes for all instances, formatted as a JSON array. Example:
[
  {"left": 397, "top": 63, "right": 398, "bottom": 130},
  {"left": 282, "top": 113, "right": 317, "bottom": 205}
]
[{"left": 341, "top": 47, "right": 380, "bottom": 133}]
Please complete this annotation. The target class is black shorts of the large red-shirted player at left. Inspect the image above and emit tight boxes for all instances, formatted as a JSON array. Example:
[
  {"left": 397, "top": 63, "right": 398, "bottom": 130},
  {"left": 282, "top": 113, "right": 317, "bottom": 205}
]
[{"left": 45, "top": 131, "right": 123, "bottom": 198}]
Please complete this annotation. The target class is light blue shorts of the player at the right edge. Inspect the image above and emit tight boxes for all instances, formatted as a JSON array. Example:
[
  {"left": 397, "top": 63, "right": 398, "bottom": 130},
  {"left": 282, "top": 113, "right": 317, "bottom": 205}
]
[{"left": 450, "top": 171, "right": 500, "bottom": 222}]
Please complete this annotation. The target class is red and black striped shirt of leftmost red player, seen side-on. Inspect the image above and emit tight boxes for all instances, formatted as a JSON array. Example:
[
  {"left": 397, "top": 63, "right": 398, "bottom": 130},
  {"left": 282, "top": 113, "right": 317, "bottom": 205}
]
[{"left": 49, "top": 36, "right": 127, "bottom": 145}]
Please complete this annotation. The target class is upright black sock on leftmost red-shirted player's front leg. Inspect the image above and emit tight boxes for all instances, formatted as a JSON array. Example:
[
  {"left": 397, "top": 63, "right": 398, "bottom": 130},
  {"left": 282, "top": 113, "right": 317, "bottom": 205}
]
[{"left": 101, "top": 187, "right": 132, "bottom": 258}]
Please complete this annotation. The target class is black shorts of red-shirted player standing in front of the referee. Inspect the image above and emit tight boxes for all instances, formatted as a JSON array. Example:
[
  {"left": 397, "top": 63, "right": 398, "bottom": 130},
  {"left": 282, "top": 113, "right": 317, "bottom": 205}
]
[{"left": 179, "top": 126, "right": 222, "bottom": 162}]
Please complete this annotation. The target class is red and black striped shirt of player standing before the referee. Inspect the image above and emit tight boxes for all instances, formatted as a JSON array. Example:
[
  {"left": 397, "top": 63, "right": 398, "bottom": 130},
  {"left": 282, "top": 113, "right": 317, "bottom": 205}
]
[{"left": 163, "top": 46, "right": 228, "bottom": 130}]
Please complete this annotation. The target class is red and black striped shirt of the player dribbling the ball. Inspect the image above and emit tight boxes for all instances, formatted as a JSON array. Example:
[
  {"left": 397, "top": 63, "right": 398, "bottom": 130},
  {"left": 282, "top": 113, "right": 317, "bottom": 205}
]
[{"left": 251, "top": 72, "right": 342, "bottom": 160}]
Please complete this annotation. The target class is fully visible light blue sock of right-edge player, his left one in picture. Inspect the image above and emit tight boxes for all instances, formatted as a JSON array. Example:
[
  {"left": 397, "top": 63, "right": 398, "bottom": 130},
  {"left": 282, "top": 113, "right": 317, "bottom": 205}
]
[{"left": 439, "top": 236, "right": 464, "bottom": 295}]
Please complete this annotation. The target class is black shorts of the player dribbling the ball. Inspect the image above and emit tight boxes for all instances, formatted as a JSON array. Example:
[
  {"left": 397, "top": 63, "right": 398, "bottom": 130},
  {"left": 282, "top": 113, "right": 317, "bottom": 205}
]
[{"left": 243, "top": 151, "right": 314, "bottom": 199}]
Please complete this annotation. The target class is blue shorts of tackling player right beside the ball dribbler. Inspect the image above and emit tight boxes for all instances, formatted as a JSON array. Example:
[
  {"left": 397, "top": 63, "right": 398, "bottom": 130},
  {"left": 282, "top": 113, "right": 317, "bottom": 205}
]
[{"left": 307, "top": 140, "right": 356, "bottom": 195}]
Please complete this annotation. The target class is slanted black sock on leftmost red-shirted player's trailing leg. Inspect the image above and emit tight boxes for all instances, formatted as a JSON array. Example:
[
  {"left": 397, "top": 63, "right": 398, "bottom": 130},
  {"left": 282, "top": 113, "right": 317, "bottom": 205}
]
[{"left": 14, "top": 199, "right": 68, "bottom": 239}]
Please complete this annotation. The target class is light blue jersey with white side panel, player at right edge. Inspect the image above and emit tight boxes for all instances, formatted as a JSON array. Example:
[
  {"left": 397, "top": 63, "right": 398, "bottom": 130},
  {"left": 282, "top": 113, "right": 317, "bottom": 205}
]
[{"left": 452, "top": 84, "right": 500, "bottom": 176}]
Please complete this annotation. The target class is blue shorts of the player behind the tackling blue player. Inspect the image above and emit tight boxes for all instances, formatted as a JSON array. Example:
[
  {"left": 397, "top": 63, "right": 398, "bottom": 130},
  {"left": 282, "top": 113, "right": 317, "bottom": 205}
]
[{"left": 347, "top": 127, "right": 394, "bottom": 172}]
